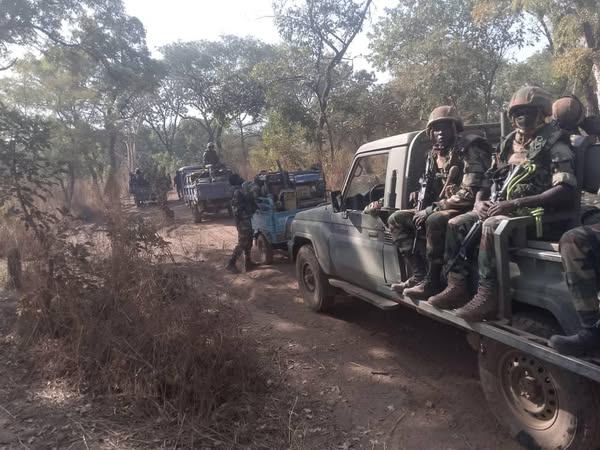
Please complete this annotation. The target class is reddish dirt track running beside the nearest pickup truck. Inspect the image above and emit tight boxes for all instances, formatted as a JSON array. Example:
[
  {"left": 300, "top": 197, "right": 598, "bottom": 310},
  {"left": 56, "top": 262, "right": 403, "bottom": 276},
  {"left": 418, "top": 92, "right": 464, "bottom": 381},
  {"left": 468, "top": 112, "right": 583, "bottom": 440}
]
[{"left": 165, "top": 200, "right": 521, "bottom": 450}]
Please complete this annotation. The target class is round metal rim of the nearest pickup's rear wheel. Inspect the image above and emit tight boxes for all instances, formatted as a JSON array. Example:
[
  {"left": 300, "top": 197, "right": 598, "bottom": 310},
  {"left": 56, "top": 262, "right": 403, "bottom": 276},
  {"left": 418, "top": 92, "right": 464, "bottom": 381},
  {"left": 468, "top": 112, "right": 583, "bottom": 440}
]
[{"left": 499, "top": 351, "right": 559, "bottom": 430}]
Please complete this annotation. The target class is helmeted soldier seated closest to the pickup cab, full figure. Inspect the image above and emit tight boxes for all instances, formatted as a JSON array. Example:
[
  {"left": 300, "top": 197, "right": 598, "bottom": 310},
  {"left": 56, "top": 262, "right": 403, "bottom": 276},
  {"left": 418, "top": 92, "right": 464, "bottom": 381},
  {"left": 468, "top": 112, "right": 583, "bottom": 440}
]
[{"left": 365, "top": 106, "right": 491, "bottom": 299}]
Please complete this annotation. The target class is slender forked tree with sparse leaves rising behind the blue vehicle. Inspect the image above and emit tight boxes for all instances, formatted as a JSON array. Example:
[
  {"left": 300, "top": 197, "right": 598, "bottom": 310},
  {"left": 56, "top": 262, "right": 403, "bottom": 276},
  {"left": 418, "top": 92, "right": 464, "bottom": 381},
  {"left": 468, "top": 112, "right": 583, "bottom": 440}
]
[{"left": 273, "top": 0, "right": 372, "bottom": 161}]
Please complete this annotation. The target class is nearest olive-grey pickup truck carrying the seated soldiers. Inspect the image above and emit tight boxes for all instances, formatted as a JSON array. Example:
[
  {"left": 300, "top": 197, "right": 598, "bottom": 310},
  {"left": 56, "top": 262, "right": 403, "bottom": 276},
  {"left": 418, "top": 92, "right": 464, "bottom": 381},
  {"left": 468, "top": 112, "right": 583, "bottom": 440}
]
[{"left": 288, "top": 124, "right": 600, "bottom": 450}]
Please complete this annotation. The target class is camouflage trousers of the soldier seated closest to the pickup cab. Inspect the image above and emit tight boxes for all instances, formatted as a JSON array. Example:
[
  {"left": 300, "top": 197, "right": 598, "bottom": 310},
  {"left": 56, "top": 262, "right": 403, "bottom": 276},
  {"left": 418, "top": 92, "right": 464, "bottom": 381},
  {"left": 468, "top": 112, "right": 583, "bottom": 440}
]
[{"left": 388, "top": 209, "right": 460, "bottom": 264}]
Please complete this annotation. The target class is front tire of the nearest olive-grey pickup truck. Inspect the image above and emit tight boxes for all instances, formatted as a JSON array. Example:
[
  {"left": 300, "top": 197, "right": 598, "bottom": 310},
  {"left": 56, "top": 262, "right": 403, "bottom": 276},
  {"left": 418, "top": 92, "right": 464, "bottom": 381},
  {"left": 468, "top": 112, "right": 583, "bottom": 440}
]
[{"left": 296, "top": 244, "right": 334, "bottom": 312}]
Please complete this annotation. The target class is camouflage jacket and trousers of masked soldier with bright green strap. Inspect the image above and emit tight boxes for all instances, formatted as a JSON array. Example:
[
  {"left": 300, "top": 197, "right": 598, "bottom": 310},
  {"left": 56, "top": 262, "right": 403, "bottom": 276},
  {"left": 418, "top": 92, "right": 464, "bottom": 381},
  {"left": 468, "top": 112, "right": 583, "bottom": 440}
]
[{"left": 446, "top": 124, "right": 577, "bottom": 280}]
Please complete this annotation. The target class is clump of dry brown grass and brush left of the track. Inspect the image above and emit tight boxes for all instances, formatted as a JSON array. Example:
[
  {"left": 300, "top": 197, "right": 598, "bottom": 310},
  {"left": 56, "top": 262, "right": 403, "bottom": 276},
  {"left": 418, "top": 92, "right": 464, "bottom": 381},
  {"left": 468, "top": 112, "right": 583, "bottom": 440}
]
[{"left": 19, "top": 209, "right": 286, "bottom": 448}]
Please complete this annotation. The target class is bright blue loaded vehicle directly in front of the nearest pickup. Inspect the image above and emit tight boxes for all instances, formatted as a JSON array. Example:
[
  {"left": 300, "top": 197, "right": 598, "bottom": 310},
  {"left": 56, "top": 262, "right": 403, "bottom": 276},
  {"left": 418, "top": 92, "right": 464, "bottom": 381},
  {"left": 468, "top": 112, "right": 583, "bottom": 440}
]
[{"left": 252, "top": 170, "right": 325, "bottom": 264}]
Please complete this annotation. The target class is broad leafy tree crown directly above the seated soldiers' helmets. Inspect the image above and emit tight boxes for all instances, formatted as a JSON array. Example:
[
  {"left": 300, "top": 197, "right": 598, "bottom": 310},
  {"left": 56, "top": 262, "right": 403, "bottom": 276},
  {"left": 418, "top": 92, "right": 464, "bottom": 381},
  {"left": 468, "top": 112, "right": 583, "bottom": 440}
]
[{"left": 371, "top": 0, "right": 525, "bottom": 120}]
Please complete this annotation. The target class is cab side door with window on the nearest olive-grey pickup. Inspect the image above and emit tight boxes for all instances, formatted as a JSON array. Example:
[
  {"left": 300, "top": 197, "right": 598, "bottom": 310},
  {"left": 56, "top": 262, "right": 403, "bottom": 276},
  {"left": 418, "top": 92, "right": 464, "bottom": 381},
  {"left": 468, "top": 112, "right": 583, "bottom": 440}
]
[{"left": 329, "top": 151, "right": 388, "bottom": 290}]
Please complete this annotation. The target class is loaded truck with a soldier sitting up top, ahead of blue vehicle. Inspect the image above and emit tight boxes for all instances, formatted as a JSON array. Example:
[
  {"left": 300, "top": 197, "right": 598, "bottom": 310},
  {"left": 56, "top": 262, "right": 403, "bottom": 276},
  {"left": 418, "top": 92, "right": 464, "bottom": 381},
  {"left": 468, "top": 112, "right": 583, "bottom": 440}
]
[{"left": 182, "top": 165, "right": 233, "bottom": 223}]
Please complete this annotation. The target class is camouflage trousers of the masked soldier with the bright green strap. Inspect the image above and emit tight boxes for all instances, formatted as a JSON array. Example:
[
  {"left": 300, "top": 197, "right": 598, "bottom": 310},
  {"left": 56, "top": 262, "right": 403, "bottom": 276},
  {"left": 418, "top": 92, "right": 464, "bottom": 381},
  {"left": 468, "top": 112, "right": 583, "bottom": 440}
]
[{"left": 445, "top": 211, "right": 509, "bottom": 280}]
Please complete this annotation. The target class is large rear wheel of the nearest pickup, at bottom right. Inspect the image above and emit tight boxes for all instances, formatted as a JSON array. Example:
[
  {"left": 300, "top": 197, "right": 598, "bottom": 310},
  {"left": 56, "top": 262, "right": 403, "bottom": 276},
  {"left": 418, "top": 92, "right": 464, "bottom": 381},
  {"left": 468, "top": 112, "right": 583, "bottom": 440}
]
[{"left": 479, "top": 314, "right": 600, "bottom": 450}]
